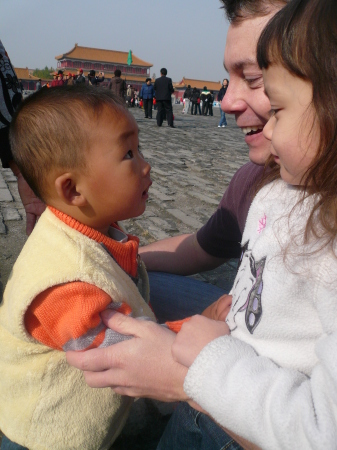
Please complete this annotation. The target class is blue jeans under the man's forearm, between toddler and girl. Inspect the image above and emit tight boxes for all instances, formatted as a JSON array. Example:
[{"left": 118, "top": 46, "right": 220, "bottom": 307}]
[{"left": 148, "top": 272, "right": 227, "bottom": 323}]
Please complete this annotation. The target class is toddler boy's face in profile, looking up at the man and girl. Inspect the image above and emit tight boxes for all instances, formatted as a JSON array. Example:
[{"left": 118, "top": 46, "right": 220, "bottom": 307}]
[{"left": 82, "top": 108, "right": 152, "bottom": 233}]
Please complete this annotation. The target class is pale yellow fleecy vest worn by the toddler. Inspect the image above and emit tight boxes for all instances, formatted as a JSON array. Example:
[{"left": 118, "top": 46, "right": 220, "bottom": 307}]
[{"left": 0, "top": 209, "right": 154, "bottom": 450}]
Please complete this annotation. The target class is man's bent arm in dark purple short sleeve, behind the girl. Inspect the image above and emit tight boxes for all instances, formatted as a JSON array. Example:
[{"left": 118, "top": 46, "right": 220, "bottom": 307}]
[{"left": 140, "top": 163, "right": 263, "bottom": 275}]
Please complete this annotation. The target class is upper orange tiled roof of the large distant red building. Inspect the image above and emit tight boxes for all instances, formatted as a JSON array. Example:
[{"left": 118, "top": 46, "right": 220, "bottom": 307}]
[{"left": 55, "top": 44, "right": 153, "bottom": 67}]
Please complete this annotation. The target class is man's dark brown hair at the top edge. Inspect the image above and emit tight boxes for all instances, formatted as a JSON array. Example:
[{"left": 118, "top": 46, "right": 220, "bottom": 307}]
[{"left": 220, "top": 0, "right": 290, "bottom": 25}]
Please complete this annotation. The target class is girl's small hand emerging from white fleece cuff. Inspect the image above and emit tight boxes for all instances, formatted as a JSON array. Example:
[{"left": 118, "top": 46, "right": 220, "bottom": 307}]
[{"left": 172, "top": 316, "right": 230, "bottom": 368}]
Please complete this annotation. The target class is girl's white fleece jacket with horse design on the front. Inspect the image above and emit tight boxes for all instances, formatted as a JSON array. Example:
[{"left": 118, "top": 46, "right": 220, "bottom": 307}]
[{"left": 184, "top": 181, "right": 337, "bottom": 450}]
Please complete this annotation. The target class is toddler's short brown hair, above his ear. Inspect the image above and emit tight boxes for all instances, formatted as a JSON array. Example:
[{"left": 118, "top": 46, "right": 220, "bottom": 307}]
[{"left": 10, "top": 86, "right": 126, "bottom": 200}]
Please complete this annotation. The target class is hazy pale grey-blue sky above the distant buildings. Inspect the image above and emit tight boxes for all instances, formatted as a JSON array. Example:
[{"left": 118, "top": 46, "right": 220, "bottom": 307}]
[{"left": 0, "top": 0, "right": 228, "bottom": 81}]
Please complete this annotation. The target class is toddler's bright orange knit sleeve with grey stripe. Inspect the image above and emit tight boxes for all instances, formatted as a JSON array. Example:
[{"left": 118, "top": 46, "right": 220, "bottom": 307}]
[{"left": 25, "top": 281, "right": 131, "bottom": 350}]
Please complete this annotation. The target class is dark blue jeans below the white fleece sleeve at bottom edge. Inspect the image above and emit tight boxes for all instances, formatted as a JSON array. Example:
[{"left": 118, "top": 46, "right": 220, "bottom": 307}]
[{"left": 157, "top": 402, "right": 242, "bottom": 450}]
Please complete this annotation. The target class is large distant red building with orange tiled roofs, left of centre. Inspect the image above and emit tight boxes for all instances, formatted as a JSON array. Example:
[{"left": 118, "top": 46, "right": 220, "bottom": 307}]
[{"left": 55, "top": 44, "right": 153, "bottom": 89}]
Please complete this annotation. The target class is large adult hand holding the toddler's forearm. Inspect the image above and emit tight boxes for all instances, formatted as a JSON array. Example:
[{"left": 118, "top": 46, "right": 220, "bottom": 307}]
[{"left": 67, "top": 311, "right": 188, "bottom": 401}]
